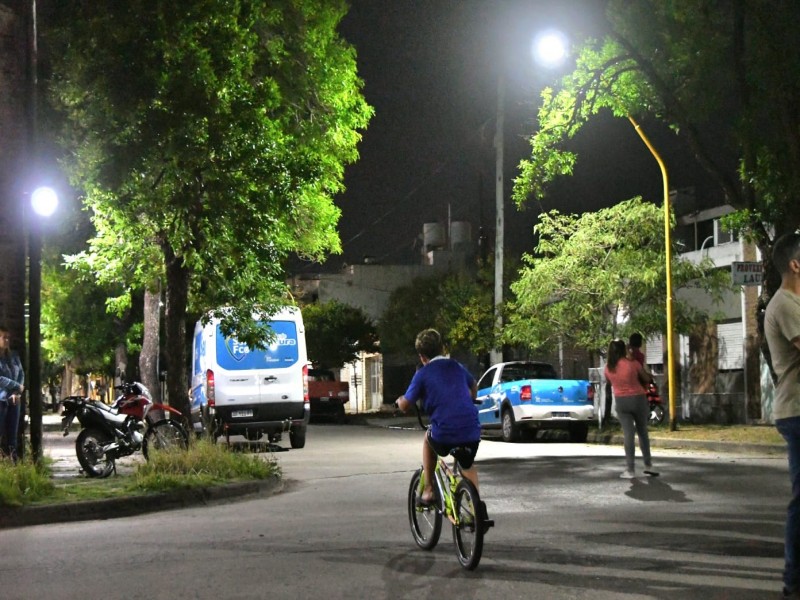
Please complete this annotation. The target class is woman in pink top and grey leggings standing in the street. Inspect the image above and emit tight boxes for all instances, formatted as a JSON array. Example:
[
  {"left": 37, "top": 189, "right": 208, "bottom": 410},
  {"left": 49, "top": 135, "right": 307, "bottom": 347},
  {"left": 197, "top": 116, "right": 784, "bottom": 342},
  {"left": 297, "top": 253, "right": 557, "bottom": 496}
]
[{"left": 605, "top": 340, "right": 658, "bottom": 479}]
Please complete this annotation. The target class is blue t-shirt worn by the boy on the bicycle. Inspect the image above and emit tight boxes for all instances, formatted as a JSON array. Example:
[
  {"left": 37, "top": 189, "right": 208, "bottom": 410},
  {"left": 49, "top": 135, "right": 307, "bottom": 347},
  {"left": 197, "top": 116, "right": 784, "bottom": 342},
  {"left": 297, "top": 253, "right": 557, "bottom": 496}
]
[{"left": 404, "top": 356, "right": 481, "bottom": 447}]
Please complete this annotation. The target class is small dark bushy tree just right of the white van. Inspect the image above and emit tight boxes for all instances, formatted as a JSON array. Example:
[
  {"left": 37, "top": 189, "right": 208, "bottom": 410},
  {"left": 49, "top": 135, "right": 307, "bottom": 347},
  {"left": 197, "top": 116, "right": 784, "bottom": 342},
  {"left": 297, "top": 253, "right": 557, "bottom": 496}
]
[{"left": 303, "top": 300, "right": 378, "bottom": 369}]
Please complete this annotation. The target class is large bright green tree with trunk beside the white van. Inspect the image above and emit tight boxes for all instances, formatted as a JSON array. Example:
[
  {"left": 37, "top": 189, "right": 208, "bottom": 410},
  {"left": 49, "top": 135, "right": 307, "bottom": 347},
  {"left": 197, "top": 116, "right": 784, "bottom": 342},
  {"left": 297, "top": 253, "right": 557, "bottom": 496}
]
[{"left": 49, "top": 0, "right": 372, "bottom": 418}]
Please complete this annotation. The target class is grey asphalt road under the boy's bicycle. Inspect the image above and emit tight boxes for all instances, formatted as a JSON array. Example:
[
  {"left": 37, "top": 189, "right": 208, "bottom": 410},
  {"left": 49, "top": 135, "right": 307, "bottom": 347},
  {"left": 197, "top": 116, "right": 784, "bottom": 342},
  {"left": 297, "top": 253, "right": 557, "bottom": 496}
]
[{"left": 0, "top": 425, "right": 789, "bottom": 600}]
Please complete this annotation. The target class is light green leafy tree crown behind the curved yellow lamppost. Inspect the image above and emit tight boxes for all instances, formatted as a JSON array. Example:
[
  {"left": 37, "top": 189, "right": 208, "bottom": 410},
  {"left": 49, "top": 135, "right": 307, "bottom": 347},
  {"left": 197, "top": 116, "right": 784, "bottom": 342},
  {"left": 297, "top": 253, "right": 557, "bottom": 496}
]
[{"left": 504, "top": 198, "right": 730, "bottom": 351}]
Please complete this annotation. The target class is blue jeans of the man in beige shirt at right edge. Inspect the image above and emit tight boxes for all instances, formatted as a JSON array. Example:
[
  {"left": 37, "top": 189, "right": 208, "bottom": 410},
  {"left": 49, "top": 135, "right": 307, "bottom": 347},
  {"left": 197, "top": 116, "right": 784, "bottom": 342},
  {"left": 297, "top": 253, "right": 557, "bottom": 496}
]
[{"left": 775, "top": 417, "right": 800, "bottom": 592}]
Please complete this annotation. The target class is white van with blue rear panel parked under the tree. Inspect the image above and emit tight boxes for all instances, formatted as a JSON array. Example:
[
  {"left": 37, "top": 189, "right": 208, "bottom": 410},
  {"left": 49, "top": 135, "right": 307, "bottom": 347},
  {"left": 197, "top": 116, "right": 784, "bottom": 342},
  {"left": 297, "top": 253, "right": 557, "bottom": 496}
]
[{"left": 192, "top": 307, "right": 310, "bottom": 448}]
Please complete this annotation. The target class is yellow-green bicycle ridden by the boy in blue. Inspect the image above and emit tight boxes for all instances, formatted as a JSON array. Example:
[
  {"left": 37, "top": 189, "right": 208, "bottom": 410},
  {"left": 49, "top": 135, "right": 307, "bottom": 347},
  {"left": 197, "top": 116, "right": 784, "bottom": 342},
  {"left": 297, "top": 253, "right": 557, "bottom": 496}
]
[{"left": 408, "top": 414, "right": 494, "bottom": 571}]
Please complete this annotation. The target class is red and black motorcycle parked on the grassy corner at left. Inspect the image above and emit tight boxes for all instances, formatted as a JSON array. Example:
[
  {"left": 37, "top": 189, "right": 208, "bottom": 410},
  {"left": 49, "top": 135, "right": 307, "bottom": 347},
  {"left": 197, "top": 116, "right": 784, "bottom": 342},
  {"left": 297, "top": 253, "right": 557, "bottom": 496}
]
[{"left": 61, "top": 382, "right": 189, "bottom": 477}]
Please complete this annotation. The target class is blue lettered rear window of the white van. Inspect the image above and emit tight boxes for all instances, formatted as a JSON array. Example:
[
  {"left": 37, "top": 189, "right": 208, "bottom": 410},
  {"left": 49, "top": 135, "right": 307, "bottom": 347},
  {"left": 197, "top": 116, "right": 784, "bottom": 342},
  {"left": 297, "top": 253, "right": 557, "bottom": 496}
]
[{"left": 216, "top": 321, "right": 299, "bottom": 371}]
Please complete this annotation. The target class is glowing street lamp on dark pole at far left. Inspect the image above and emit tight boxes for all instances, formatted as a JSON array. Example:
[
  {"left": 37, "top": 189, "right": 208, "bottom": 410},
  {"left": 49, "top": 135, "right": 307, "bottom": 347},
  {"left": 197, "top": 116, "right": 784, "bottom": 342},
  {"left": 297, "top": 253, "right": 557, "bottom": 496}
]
[{"left": 27, "top": 187, "right": 58, "bottom": 462}]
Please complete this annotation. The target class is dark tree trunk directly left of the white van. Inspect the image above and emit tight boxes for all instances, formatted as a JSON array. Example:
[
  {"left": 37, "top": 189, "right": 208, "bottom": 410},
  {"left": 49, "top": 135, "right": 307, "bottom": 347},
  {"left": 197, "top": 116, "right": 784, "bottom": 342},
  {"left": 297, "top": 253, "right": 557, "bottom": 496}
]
[{"left": 164, "top": 244, "right": 189, "bottom": 420}]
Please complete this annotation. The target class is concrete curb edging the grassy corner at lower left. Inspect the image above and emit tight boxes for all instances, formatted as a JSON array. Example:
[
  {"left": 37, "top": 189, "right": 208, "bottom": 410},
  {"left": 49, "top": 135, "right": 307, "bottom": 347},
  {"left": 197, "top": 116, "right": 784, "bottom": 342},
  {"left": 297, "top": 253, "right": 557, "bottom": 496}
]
[{"left": 0, "top": 477, "right": 283, "bottom": 529}]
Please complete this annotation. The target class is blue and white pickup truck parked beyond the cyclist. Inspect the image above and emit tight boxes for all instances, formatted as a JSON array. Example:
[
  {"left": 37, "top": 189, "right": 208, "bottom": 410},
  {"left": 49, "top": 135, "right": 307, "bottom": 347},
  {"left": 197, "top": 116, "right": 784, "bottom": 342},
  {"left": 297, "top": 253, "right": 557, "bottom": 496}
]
[{"left": 476, "top": 361, "right": 595, "bottom": 442}]
